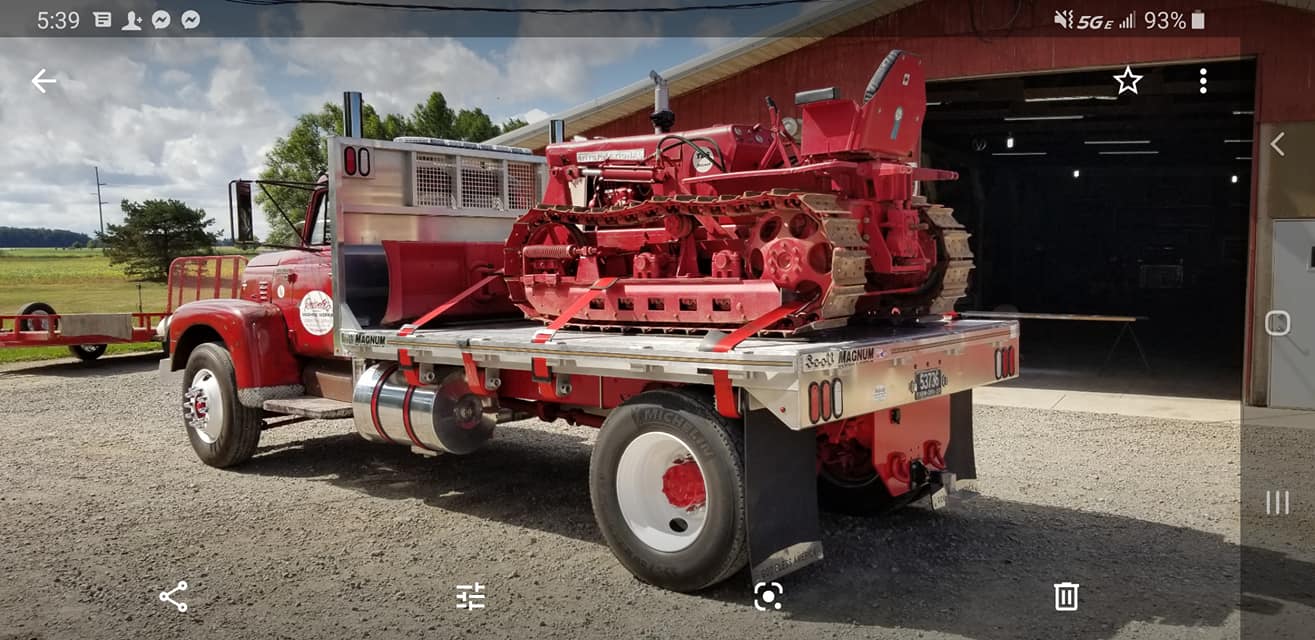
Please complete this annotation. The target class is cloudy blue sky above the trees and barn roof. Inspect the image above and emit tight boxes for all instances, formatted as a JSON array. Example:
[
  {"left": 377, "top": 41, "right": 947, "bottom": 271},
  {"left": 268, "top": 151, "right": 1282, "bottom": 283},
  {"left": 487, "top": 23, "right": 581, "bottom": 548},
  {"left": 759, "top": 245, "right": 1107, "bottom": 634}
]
[{"left": 0, "top": 38, "right": 730, "bottom": 239}]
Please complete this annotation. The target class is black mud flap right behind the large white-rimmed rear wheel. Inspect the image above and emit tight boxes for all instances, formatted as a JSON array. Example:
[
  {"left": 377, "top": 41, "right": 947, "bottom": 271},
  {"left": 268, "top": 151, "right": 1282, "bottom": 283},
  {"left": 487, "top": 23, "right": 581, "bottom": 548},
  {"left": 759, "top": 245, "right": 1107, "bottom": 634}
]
[{"left": 744, "top": 409, "right": 822, "bottom": 583}]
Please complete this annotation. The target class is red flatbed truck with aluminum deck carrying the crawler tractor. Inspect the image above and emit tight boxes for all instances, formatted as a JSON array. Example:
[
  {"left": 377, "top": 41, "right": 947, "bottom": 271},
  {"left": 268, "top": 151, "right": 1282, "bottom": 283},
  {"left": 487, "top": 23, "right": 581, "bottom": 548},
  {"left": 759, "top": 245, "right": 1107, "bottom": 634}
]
[{"left": 160, "top": 138, "right": 1018, "bottom": 591}]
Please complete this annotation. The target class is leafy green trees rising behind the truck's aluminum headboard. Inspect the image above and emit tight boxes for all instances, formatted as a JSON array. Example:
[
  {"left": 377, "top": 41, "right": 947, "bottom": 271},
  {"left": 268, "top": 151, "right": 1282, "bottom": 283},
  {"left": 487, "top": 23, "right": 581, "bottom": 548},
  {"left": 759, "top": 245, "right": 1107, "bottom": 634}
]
[{"left": 255, "top": 91, "right": 525, "bottom": 244}]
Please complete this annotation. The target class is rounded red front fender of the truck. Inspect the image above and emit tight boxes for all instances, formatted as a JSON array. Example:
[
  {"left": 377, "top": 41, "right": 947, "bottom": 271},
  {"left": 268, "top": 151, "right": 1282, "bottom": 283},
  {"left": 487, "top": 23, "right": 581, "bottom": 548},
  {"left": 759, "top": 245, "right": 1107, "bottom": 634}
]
[{"left": 168, "top": 300, "right": 305, "bottom": 407}]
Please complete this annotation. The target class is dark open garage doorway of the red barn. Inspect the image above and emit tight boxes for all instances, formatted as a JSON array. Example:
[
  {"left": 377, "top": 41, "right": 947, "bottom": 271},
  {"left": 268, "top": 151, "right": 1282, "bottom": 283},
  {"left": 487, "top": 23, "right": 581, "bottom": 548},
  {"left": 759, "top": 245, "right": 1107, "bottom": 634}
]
[{"left": 923, "top": 60, "right": 1256, "bottom": 398}]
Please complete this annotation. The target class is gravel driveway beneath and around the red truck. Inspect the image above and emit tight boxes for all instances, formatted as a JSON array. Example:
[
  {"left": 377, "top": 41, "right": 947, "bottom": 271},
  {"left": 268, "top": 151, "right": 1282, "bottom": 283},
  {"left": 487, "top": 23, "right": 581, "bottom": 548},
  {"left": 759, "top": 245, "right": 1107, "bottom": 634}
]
[{"left": 0, "top": 356, "right": 1272, "bottom": 640}]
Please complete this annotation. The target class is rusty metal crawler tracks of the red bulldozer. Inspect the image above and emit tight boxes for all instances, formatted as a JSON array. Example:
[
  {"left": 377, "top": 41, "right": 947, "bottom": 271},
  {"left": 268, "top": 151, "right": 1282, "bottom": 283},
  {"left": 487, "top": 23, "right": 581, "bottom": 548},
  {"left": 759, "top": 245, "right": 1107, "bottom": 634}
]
[{"left": 522, "top": 189, "right": 973, "bottom": 334}]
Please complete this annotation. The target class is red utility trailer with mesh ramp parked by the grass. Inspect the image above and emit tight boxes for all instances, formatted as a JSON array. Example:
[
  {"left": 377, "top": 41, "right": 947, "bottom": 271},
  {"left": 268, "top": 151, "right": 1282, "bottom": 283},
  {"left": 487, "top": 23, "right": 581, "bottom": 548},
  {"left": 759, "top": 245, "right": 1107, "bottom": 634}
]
[{"left": 0, "top": 255, "right": 246, "bottom": 361}]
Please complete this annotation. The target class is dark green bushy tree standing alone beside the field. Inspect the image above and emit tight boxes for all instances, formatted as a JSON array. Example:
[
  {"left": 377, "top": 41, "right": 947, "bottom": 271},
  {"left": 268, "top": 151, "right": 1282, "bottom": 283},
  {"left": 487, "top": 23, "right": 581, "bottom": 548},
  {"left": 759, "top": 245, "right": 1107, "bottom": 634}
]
[{"left": 96, "top": 200, "right": 218, "bottom": 281}]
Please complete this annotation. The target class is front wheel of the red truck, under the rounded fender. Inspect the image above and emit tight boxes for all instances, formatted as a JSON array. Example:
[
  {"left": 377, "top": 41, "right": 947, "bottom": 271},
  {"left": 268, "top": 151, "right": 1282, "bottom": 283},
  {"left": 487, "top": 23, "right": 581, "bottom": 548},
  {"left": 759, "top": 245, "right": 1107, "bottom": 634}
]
[{"left": 183, "top": 342, "right": 264, "bottom": 469}]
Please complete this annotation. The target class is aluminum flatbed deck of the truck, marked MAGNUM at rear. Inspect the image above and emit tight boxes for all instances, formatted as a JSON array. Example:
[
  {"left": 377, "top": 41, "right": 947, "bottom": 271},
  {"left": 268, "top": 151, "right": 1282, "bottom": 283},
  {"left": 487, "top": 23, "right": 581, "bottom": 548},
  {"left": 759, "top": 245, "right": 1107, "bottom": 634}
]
[{"left": 338, "top": 319, "right": 1018, "bottom": 428}]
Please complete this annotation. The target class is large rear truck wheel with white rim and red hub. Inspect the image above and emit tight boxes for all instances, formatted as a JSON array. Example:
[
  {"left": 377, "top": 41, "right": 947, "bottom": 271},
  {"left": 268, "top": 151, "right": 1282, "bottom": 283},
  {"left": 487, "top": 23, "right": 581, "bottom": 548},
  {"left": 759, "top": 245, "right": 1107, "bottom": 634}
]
[{"left": 589, "top": 389, "right": 748, "bottom": 591}]
